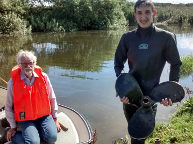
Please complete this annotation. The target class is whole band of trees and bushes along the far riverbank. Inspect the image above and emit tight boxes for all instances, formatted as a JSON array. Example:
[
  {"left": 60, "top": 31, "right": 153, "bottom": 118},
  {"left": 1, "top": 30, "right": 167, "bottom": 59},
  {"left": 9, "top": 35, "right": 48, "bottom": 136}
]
[{"left": 0, "top": 0, "right": 193, "bottom": 34}]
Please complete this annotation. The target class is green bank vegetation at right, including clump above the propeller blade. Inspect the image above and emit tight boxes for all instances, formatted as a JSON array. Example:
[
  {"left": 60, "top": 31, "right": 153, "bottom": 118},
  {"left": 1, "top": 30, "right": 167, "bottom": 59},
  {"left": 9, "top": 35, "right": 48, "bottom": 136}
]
[{"left": 114, "top": 55, "right": 193, "bottom": 144}]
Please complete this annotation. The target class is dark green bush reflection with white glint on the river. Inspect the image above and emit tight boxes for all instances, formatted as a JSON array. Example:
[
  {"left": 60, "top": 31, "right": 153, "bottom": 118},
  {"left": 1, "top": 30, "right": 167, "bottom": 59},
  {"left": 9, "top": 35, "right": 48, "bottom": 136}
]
[{"left": 32, "top": 31, "right": 123, "bottom": 72}]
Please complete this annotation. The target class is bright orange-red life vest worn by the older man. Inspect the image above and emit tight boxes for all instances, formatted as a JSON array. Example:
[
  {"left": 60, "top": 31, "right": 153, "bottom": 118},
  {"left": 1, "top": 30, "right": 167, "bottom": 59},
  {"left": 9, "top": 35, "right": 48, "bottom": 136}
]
[{"left": 11, "top": 66, "right": 51, "bottom": 121}]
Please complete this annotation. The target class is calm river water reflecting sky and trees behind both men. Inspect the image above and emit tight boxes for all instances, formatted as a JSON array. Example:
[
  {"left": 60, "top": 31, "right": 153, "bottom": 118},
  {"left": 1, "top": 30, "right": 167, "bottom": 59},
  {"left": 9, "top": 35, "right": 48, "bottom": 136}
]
[{"left": 0, "top": 25, "right": 193, "bottom": 144}]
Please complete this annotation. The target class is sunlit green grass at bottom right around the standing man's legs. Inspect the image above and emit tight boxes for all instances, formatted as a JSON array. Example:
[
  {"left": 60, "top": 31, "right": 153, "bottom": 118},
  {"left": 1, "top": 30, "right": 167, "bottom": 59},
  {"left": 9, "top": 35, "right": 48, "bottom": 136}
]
[{"left": 115, "top": 97, "right": 193, "bottom": 144}]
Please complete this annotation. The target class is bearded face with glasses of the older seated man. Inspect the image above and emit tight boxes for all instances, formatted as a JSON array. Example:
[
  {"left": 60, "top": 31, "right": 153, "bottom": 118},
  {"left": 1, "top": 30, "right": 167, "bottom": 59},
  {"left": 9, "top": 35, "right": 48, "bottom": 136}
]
[{"left": 20, "top": 56, "right": 34, "bottom": 78}]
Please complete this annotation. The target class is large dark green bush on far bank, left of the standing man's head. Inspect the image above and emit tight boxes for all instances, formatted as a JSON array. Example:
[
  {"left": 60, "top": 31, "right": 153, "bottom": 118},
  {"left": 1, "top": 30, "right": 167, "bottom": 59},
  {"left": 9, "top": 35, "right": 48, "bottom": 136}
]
[{"left": 27, "top": 0, "right": 126, "bottom": 31}]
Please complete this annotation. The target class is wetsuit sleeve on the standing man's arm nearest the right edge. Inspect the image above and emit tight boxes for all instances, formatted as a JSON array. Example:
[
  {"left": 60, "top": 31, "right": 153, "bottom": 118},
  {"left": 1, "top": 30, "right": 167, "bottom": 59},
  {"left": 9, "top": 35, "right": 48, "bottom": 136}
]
[{"left": 165, "top": 34, "right": 182, "bottom": 82}]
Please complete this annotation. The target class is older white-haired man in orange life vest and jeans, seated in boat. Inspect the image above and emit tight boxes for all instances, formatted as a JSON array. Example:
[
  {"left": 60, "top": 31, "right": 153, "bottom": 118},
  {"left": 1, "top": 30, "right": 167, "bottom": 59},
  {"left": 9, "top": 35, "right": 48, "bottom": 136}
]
[{"left": 5, "top": 50, "right": 61, "bottom": 144}]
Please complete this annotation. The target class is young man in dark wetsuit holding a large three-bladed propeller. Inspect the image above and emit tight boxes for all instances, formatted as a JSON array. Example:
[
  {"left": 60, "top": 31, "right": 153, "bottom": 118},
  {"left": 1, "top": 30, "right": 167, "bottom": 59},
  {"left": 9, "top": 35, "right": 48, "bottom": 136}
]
[{"left": 114, "top": 0, "right": 182, "bottom": 144}]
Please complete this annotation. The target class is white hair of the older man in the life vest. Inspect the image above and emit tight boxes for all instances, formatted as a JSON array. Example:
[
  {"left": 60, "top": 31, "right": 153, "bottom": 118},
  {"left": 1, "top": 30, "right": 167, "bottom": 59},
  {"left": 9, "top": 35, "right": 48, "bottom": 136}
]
[{"left": 16, "top": 50, "right": 37, "bottom": 65}]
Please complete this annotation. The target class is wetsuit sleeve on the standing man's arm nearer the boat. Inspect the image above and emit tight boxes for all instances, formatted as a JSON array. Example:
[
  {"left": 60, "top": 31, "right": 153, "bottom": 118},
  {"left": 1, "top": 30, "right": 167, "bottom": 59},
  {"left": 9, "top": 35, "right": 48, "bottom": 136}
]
[{"left": 114, "top": 34, "right": 127, "bottom": 77}]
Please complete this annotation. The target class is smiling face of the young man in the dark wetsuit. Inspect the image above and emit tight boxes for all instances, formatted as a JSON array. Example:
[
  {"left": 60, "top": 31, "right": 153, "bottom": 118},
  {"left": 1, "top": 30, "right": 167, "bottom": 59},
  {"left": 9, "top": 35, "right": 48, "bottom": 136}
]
[{"left": 134, "top": 5, "right": 156, "bottom": 28}]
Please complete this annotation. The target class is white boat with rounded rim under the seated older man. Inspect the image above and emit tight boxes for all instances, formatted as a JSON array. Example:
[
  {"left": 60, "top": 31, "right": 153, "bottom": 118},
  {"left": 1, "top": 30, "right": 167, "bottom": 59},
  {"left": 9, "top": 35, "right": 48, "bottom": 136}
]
[{"left": 0, "top": 86, "right": 96, "bottom": 144}]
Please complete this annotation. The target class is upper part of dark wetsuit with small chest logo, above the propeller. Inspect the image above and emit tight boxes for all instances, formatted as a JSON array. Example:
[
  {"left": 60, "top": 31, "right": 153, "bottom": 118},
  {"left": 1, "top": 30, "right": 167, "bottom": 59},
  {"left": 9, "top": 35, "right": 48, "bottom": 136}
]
[{"left": 114, "top": 25, "right": 182, "bottom": 95}]
